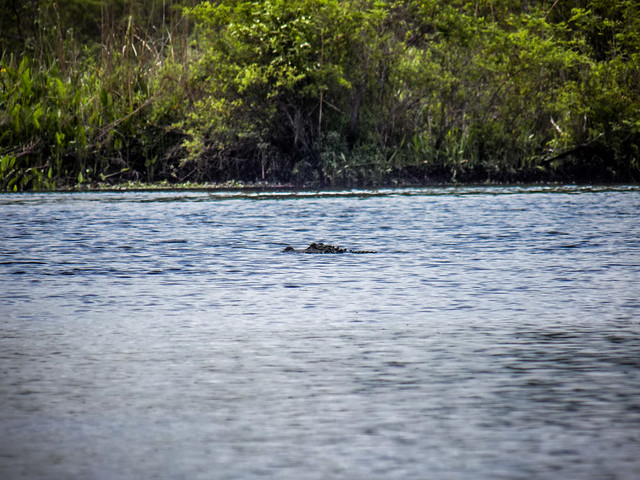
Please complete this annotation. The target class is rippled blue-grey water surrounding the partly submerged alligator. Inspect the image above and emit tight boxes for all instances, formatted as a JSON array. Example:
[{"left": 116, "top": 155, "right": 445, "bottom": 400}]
[{"left": 0, "top": 187, "right": 640, "bottom": 480}]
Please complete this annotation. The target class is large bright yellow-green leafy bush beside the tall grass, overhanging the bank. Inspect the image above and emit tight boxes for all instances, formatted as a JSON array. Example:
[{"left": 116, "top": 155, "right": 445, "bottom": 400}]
[{"left": 184, "top": 0, "right": 398, "bottom": 180}]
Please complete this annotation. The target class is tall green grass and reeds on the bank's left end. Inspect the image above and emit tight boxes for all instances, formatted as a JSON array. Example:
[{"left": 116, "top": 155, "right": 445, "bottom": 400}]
[{"left": 0, "top": 2, "right": 188, "bottom": 191}]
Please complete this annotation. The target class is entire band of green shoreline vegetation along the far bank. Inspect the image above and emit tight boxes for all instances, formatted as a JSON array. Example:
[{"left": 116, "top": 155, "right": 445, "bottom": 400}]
[{"left": 0, "top": 0, "right": 640, "bottom": 191}]
